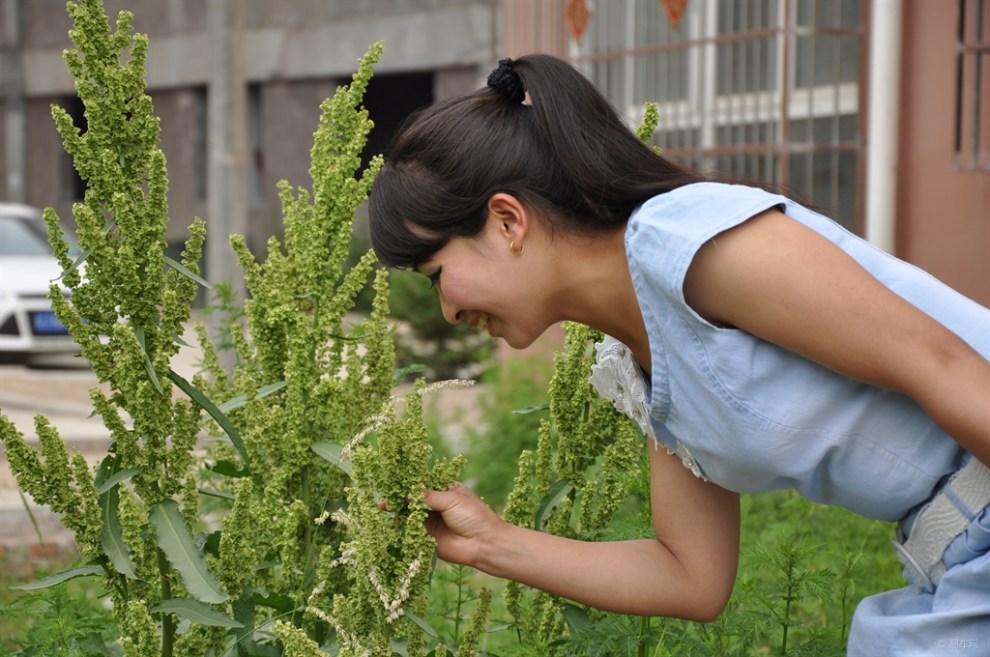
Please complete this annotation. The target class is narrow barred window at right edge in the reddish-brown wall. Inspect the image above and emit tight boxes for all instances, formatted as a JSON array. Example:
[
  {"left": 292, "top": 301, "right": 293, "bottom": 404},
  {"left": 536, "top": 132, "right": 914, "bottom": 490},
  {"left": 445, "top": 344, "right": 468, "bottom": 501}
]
[{"left": 953, "top": 0, "right": 990, "bottom": 171}]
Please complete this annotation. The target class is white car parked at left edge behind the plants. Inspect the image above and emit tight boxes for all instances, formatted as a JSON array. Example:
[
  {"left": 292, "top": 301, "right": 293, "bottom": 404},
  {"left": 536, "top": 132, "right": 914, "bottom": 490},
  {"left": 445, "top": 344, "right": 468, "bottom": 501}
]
[{"left": 0, "top": 203, "right": 79, "bottom": 356}]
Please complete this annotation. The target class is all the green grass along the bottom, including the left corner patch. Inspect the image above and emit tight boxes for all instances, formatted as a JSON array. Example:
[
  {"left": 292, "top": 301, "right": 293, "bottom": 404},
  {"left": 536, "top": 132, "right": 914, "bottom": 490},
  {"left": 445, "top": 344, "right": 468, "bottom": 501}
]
[{"left": 0, "top": 491, "right": 903, "bottom": 657}]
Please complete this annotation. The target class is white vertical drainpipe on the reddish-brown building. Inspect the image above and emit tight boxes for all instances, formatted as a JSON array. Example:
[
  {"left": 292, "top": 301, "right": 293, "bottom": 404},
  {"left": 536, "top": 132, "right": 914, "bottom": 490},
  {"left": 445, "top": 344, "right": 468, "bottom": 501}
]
[{"left": 865, "top": 0, "right": 903, "bottom": 253}]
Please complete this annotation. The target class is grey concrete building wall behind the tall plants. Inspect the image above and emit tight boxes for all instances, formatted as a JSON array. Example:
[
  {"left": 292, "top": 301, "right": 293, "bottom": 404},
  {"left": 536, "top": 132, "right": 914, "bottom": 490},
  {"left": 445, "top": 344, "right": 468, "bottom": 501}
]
[{"left": 0, "top": 0, "right": 497, "bottom": 264}]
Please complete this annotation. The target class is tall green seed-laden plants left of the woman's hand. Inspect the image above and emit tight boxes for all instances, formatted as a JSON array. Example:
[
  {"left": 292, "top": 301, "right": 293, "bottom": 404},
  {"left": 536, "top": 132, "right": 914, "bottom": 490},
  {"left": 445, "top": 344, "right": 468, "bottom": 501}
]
[{"left": 0, "top": 0, "right": 459, "bottom": 657}]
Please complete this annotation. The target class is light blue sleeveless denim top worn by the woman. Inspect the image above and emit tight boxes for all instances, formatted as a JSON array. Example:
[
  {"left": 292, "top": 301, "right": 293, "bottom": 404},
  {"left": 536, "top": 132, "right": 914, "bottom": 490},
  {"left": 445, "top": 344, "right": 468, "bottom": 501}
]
[{"left": 625, "top": 183, "right": 990, "bottom": 520}]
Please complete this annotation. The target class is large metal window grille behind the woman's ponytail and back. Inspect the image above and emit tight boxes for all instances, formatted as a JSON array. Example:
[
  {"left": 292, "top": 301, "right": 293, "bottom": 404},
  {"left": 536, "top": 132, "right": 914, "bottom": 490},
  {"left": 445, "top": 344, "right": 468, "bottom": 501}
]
[{"left": 571, "top": 0, "right": 872, "bottom": 232}]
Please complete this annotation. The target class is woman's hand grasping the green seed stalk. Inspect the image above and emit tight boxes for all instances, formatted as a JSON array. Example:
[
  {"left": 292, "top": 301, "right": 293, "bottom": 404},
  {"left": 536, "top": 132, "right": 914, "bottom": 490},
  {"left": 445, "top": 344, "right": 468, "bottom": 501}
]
[{"left": 423, "top": 483, "right": 507, "bottom": 567}]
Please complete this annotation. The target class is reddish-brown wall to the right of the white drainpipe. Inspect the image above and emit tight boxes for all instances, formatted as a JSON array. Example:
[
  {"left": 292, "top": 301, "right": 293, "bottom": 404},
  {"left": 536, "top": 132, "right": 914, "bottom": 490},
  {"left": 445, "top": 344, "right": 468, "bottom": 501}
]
[{"left": 897, "top": 2, "right": 990, "bottom": 305}]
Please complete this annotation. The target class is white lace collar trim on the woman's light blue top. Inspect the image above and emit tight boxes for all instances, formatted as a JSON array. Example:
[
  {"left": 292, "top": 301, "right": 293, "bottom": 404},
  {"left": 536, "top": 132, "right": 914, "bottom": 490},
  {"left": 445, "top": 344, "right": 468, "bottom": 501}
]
[{"left": 588, "top": 336, "right": 707, "bottom": 481}]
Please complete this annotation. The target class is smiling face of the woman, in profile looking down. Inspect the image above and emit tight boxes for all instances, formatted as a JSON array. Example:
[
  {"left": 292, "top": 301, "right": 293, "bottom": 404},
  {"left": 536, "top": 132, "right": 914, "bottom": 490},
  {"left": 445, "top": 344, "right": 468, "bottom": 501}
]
[{"left": 419, "top": 204, "right": 559, "bottom": 349}]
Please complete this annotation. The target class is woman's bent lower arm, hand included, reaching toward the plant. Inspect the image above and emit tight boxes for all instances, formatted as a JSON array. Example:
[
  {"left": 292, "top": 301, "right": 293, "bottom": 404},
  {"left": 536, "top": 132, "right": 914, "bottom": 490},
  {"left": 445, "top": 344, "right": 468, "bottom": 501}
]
[{"left": 426, "top": 440, "right": 739, "bottom": 621}]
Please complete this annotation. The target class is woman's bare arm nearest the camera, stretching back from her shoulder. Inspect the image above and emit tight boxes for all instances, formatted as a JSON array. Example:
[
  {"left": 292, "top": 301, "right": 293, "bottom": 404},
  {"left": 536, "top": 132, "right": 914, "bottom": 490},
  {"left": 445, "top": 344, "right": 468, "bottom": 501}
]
[{"left": 684, "top": 210, "right": 990, "bottom": 464}]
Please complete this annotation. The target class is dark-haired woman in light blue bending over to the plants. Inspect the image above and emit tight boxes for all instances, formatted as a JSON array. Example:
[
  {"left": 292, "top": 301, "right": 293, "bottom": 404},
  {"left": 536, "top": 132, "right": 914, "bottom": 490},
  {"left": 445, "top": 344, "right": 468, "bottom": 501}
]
[{"left": 370, "top": 55, "right": 990, "bottom": 656}]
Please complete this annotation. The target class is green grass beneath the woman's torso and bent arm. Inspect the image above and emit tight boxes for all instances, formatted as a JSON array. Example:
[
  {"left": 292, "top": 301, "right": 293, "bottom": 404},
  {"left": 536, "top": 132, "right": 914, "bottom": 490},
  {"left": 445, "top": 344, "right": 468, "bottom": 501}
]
[{"left": 429, "top": 491, "right": 904, "bottom": 657}]
